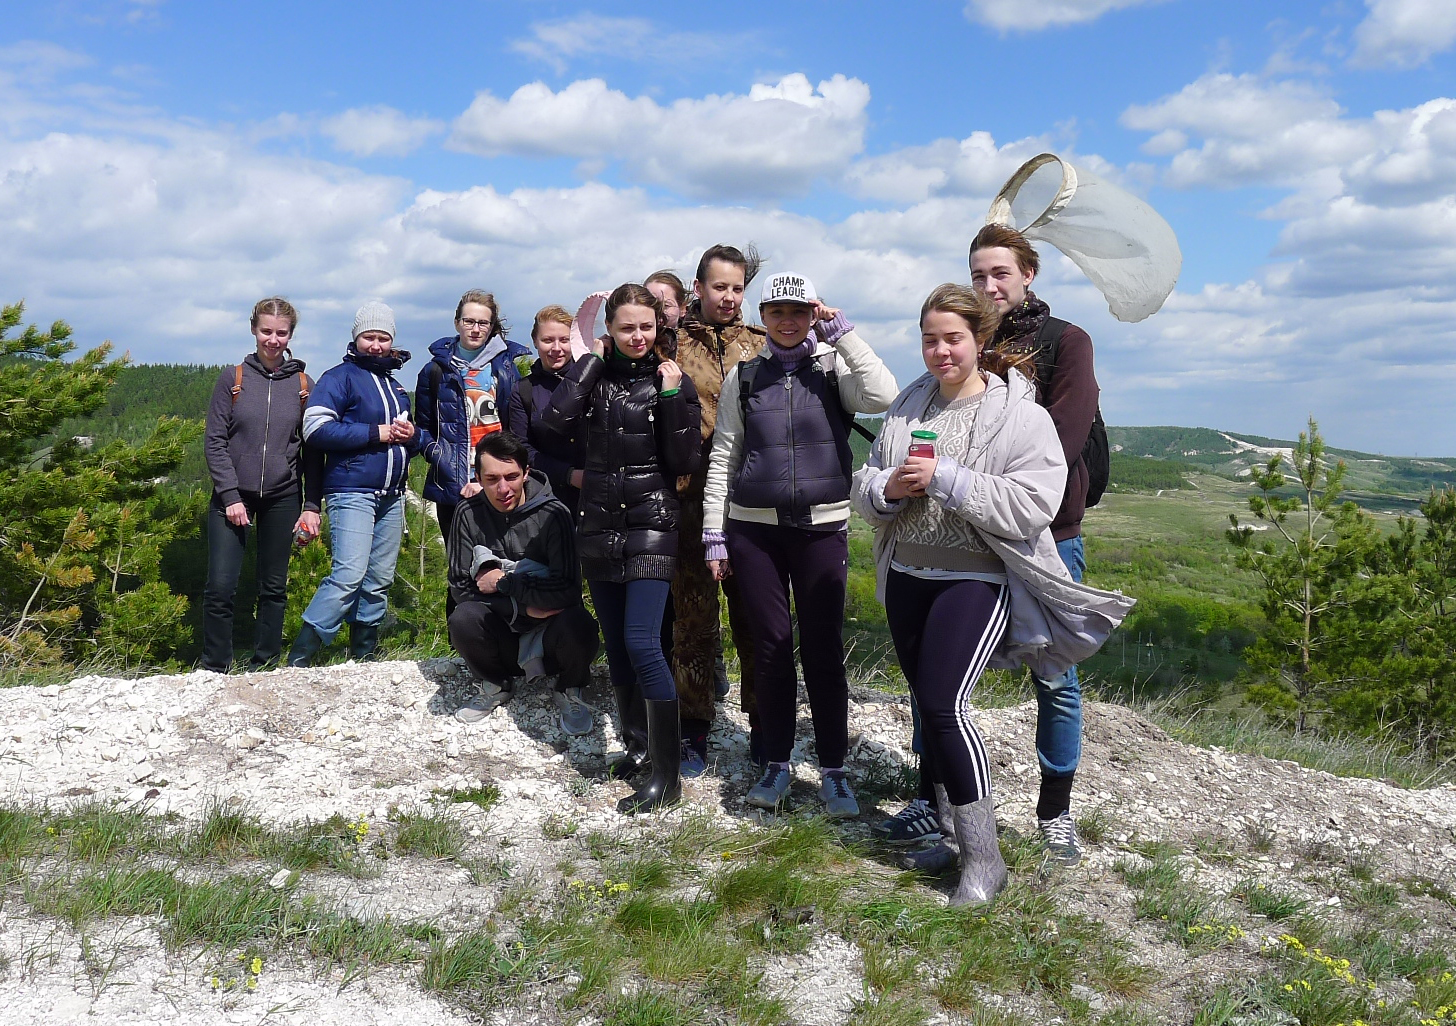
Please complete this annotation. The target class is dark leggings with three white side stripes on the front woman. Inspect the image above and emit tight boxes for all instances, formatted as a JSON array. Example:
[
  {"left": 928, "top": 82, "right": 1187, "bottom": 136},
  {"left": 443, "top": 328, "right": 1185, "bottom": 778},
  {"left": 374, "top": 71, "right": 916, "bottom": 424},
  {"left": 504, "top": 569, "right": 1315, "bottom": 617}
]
[{"left": 885, "top": 570, "right": 1010, "bottom": 805}]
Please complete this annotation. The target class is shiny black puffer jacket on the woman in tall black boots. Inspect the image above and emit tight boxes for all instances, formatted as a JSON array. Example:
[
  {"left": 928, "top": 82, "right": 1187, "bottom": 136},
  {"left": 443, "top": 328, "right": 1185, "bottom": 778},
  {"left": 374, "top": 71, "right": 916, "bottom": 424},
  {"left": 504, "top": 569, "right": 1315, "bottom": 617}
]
[{"left": 542, "top": 352, "right": 702, "bottom": 582}]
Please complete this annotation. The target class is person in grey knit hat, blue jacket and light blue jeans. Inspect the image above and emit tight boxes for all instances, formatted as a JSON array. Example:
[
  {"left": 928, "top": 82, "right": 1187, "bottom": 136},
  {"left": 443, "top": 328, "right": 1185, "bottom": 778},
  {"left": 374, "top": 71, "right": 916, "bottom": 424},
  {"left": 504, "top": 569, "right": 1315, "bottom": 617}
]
[{"left": 288, "top": 303, "right": 428, "bottom": 667}]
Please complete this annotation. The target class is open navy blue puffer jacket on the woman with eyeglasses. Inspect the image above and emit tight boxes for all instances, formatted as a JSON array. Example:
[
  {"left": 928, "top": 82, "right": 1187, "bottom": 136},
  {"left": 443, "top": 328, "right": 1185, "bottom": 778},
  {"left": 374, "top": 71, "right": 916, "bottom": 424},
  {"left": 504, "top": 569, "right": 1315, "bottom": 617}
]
[{"left": 415, "top": 335, "right": 531, "bottom": 506}]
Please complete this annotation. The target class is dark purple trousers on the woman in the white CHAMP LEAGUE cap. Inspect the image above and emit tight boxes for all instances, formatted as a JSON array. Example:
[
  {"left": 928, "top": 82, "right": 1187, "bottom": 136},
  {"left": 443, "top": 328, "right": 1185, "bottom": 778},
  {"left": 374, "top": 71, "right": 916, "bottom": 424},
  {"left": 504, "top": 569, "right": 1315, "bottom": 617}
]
[{"left": 727, "top": 520, "right": 849, "bottom": 768}]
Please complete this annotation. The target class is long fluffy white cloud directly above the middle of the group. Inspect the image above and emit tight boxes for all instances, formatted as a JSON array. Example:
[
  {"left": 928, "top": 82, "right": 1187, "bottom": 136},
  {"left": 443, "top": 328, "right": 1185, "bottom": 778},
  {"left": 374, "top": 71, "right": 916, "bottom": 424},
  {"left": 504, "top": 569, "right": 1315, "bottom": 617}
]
[{"left": 450, "top": 74, "right": 869, "bottom": 199}]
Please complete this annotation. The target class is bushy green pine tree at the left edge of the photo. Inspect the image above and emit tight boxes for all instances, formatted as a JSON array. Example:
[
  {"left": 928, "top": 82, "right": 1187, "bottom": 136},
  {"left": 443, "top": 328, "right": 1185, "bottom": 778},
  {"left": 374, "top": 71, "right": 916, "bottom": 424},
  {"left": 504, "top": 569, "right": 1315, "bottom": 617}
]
[{"left": 0, "top": 304, "right": 202, "bottom": 669}]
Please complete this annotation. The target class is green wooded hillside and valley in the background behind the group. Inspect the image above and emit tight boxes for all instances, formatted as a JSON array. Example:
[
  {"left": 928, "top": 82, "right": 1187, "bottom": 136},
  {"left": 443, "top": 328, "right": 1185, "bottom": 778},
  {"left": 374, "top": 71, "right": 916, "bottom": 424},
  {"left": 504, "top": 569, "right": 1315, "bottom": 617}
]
[{"left": 11, "top": 340, "right": 1456, "bottom": 762}]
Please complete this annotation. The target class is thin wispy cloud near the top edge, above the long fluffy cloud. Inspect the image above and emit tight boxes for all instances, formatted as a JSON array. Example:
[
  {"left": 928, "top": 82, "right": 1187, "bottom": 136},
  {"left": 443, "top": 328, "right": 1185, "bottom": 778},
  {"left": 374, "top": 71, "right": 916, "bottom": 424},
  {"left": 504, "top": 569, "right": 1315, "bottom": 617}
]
[{"left": 511, "top": 13, "right": 754, "bottom": 74}]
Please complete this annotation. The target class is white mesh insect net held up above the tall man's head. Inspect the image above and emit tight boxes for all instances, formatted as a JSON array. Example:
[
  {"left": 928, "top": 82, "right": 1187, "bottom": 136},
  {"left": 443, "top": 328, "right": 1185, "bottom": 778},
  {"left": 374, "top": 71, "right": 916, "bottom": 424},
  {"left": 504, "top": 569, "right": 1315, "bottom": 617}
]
[{"left": 986, "top": 153, "right": 1182, "bottom": 320}]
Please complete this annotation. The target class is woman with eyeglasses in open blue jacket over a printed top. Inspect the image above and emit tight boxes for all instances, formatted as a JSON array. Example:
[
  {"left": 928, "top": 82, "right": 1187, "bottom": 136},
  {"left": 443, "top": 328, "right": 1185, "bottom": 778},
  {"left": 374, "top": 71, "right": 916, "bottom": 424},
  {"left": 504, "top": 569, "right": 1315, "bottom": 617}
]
[{"left": 415, "top": 288, "right": 530, "bottom": 567}]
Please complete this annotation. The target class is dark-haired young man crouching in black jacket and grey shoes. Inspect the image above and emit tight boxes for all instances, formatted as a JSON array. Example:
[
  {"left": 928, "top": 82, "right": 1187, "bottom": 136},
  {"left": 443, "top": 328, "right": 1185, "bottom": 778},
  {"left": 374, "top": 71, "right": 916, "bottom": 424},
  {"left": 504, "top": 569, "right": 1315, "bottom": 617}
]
[{"left": 448, "top": 431, "right": 598, "bottom": 733}]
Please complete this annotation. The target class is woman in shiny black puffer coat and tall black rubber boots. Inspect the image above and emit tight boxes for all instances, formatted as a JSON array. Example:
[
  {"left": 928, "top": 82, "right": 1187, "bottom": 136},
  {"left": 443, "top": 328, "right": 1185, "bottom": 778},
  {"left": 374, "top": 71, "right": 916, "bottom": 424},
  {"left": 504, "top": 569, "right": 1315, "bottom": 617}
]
[{"left": 542, "top": 285, "right": 702, "bottom": 812}]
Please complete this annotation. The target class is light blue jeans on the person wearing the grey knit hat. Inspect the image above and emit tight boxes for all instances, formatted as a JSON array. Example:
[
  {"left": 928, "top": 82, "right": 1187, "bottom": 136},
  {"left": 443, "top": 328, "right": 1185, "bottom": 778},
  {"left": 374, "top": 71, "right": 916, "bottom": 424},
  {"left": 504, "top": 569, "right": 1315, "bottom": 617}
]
[{"left": 303, "top": 492, "right": 405, "bottom": 645}]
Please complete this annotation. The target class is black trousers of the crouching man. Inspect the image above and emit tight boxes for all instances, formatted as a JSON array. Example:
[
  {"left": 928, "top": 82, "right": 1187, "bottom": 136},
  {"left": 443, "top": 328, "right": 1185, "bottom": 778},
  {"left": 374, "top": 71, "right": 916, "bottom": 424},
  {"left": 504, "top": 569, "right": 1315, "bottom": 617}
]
[{"left": 450, "top": 601, "right": 598, "bottom": 691}]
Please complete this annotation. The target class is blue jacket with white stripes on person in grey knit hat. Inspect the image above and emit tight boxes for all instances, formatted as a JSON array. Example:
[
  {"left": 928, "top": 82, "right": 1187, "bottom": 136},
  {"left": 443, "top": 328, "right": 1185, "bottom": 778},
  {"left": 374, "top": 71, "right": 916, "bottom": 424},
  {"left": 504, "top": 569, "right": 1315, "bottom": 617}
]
[{"left": 303, "top": 342, "right": 430, "bottom": 495}]
